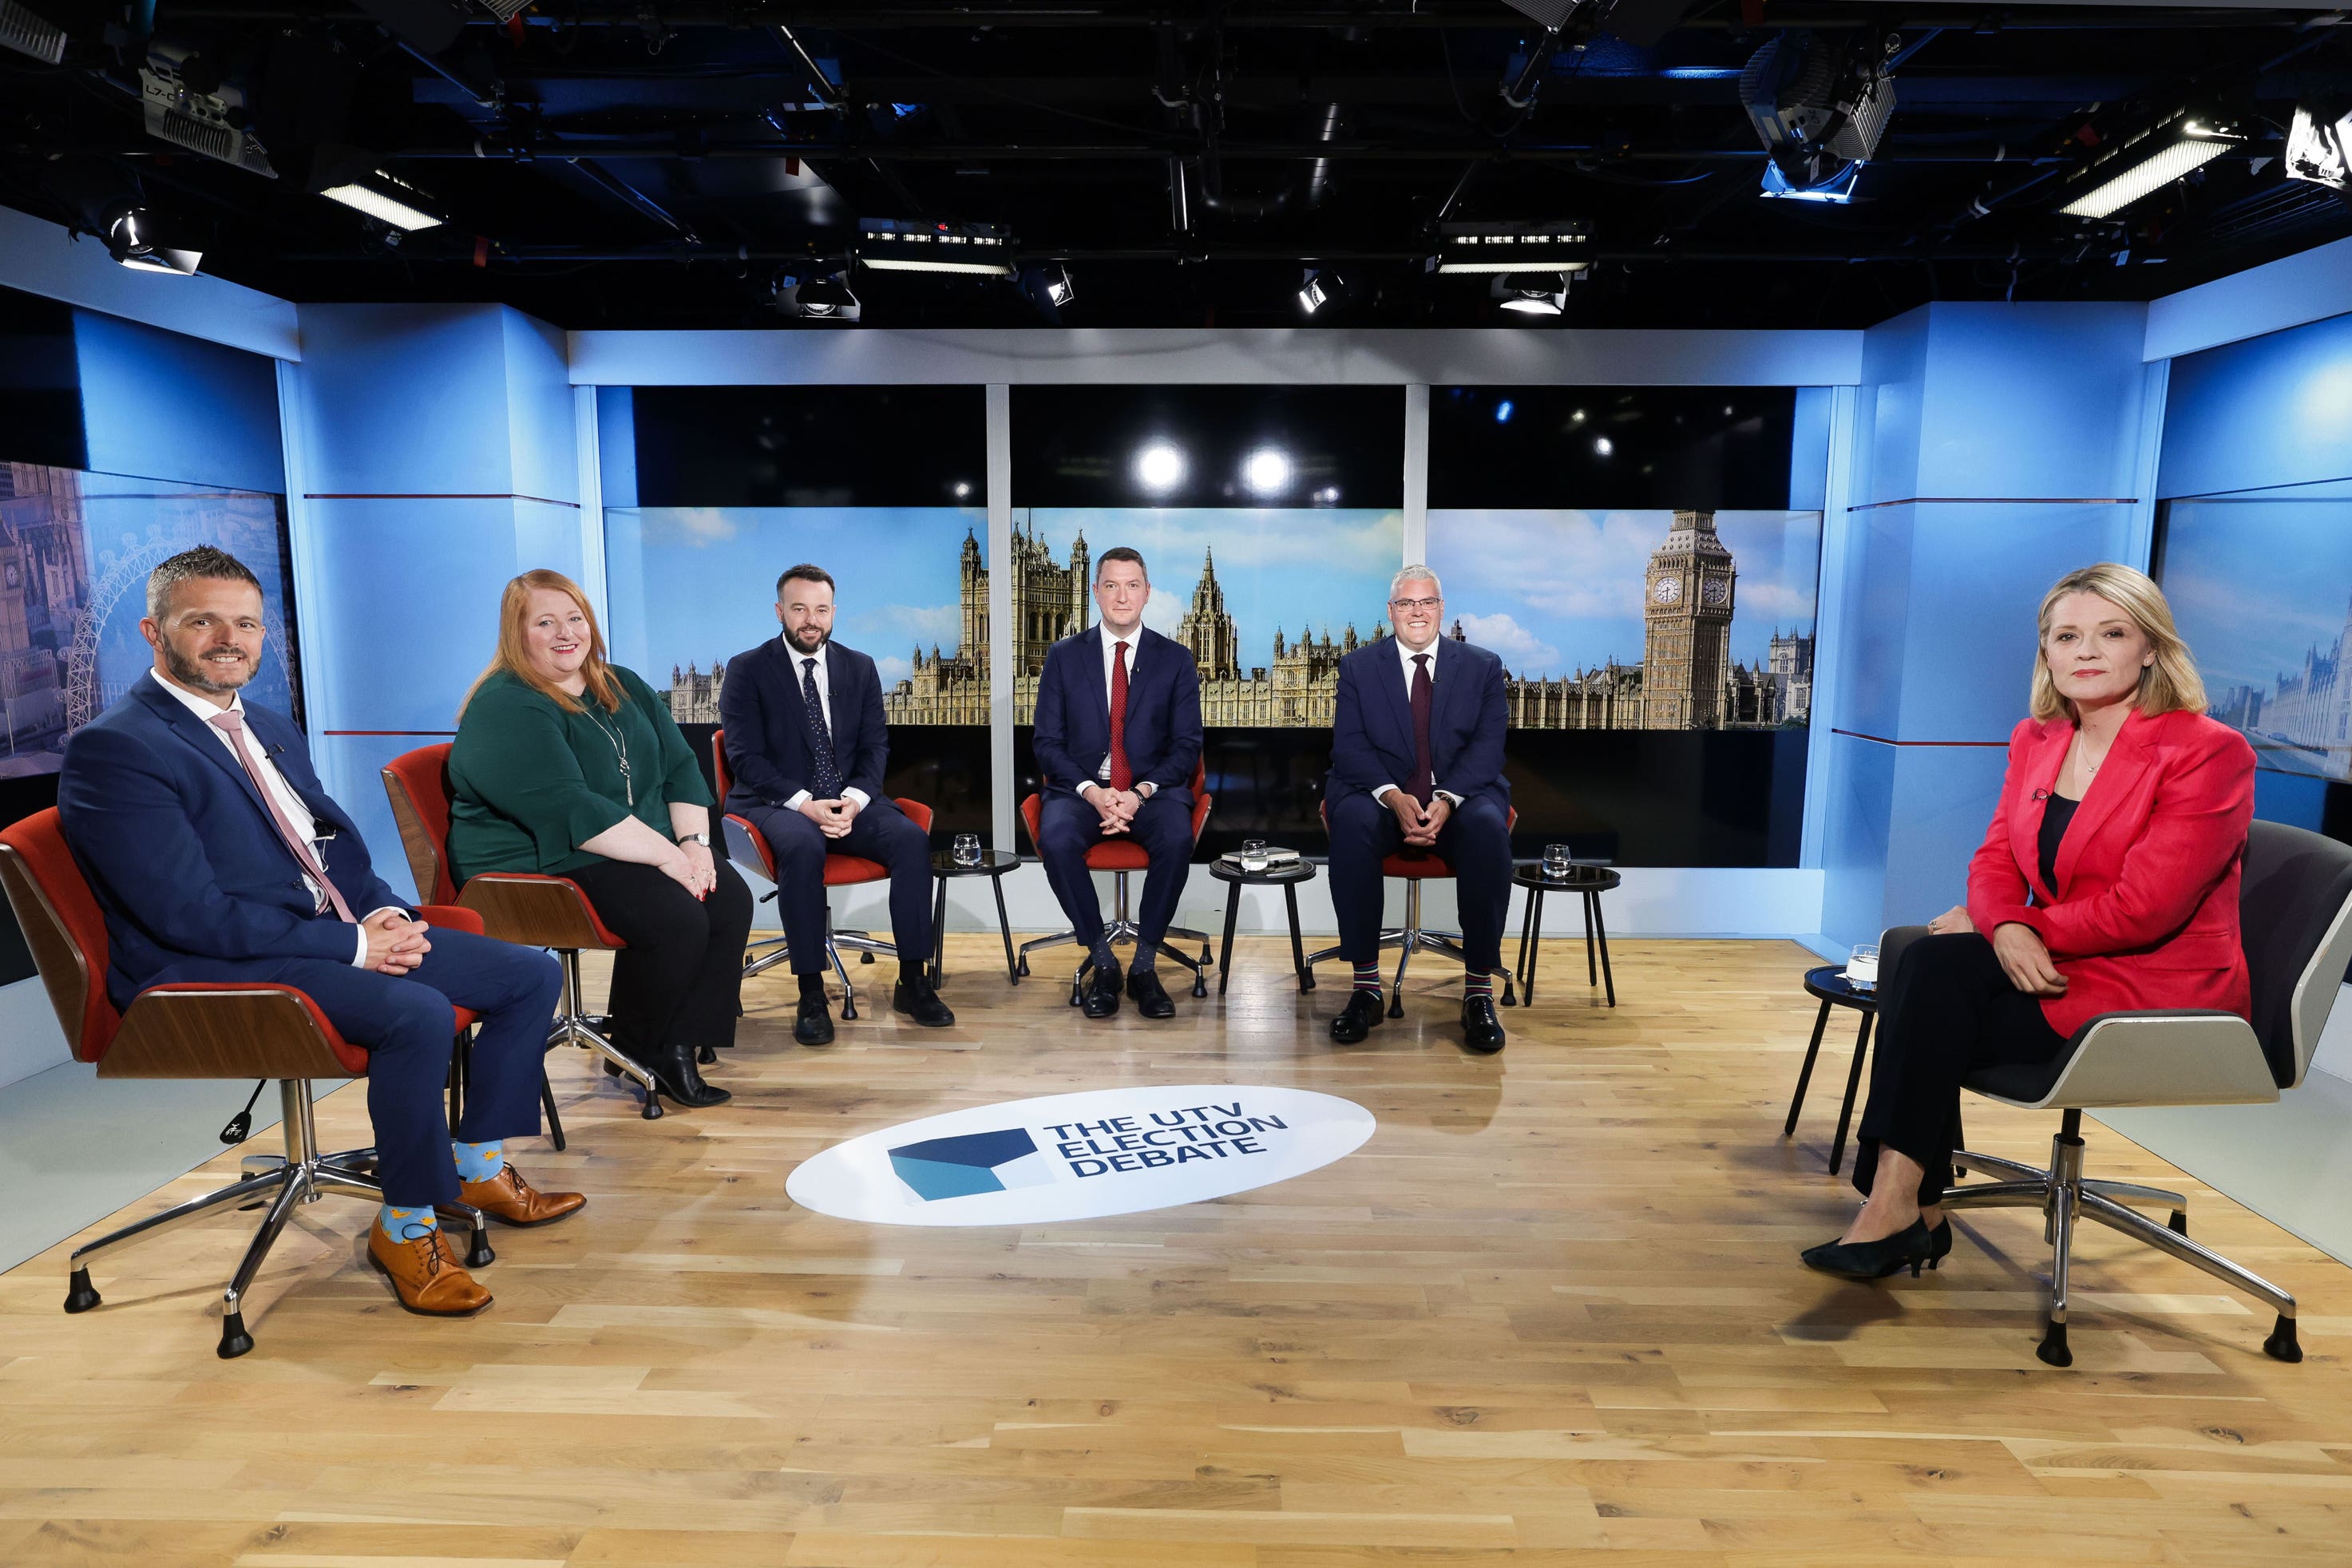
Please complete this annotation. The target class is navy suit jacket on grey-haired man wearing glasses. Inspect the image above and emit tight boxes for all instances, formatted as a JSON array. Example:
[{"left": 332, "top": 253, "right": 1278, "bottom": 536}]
[{"left": 1327, "top": 637, "right": 1510, "bottom": 806}]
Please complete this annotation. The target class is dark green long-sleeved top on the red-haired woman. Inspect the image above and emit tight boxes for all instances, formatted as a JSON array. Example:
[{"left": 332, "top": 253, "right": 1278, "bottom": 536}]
[{"left": 449, "top": 665, "right": 711, "bottom": 886}]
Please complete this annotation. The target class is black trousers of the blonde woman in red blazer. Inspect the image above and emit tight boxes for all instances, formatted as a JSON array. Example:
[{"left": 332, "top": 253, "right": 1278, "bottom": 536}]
[{"left": 1853, "top": 931, "right": 2065, "bottom": 1208}]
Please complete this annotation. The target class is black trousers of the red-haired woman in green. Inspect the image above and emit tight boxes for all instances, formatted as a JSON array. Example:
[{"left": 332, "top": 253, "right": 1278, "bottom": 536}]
[{"left": 564, "top": 861, "right": 750, "bottom": 1060}]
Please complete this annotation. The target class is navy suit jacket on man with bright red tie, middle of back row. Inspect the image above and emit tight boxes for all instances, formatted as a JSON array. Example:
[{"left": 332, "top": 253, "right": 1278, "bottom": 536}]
[{"left": 1035, "top": 623, "right": 1199, "bottom": 792}]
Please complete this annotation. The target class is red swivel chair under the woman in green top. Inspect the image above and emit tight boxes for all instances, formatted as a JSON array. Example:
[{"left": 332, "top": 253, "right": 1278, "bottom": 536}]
[{"left": 383, "top": 745, "right": 661, "bottom": 1133}]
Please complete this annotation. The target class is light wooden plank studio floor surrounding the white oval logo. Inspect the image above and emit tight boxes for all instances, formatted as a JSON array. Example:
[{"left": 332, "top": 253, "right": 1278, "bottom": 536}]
[{"left": 0, "top": 938, "right": 2352, "bottom": 1568}]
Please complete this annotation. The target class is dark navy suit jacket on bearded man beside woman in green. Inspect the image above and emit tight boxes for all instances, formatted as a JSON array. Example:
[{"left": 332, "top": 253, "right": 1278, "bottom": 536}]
[{"left": 719, "top": 637, "right": 889, "bottom": 811}]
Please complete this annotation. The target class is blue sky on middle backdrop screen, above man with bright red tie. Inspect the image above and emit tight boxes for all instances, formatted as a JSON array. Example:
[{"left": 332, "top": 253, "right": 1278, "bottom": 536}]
[{"left": 1014, "top": 505, "right": 1404, "bottom": 672}]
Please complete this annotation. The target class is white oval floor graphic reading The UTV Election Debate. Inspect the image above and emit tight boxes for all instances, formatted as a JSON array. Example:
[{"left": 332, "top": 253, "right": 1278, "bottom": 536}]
[{"left": 786, "top": 1083, "right": 1373, "bottom": 1225}]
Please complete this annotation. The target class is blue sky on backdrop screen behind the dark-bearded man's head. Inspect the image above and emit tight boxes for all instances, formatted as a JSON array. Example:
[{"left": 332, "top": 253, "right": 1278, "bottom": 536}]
[{"left": 604, "top": 505, "right": 988, "bottom": 689}]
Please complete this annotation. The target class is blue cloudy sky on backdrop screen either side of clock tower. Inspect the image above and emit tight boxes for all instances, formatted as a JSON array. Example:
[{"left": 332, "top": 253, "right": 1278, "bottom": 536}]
[{"left": 1430, "top": 510, "right": 1820, "bottom": 675}]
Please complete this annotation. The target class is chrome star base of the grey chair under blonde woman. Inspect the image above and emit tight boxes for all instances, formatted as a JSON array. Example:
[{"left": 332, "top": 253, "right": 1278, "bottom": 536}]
[{"left": 1942, "top": 1110, "right": 2303, "bottom": 1366}]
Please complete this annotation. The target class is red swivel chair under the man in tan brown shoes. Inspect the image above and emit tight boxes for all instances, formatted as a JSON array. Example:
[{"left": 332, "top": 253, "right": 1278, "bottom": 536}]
[{"left": 0, "top": 809, "right": 494, "bottom": 1361}]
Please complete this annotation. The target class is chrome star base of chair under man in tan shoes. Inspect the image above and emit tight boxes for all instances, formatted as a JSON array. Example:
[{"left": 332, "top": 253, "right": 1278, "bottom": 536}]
[{"left": 65, "top": 1079, "right": 497, "bottom": 1361}]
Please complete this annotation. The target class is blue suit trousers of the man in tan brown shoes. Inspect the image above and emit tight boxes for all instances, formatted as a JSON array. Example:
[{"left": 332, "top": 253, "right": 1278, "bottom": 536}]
[{"left": 148, "top": 917, "right": 564, "bottom": 1208}]
